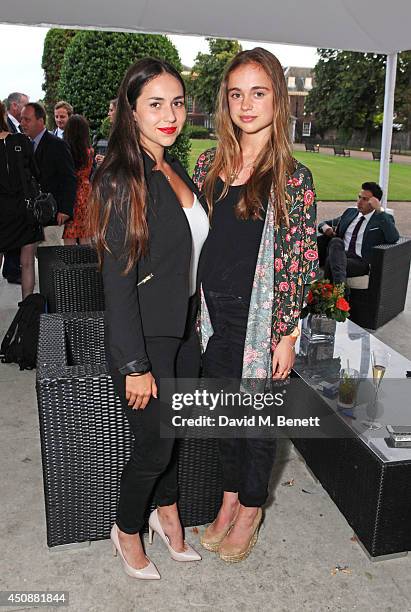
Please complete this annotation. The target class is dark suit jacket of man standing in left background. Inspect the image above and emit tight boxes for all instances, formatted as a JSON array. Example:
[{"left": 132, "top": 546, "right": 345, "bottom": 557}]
[{"left": 34, "top": 130, "right": 77, "bottom": 217}]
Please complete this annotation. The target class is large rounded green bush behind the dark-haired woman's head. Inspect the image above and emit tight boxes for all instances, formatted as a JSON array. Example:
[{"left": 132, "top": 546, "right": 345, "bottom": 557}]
[{"left": 58, "top": 31, "right": 190, "bottom": 167}]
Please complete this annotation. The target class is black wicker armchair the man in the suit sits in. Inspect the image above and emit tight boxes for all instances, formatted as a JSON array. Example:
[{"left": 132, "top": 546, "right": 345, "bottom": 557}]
[{"left": 317, "top": 234, "right": 411, "bottom": 329}]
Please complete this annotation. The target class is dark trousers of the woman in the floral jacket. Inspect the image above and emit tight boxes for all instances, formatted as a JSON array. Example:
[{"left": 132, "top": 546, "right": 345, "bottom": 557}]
[{"left": 203, "top": 291, "right": 276, "bottom": 507}]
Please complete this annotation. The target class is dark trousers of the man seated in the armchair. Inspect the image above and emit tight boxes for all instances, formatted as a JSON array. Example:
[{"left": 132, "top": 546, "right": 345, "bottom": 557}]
[{"left": 324, "top": 237, "right": 370, "bottom": 284}]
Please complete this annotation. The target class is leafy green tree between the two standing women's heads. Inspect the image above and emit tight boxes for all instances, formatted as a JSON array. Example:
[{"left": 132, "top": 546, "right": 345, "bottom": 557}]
[{"left": 189, "top": 38, "right": 241, "bottom": 114}]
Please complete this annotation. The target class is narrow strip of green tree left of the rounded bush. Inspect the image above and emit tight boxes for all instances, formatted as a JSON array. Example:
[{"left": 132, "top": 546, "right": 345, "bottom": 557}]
[{"left": 41, "top": 28, "right": 76, "bottom": 127}]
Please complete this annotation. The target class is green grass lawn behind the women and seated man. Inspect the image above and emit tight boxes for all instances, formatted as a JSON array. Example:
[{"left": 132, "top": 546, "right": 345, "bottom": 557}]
[{"left": 190, "top": 140, "right": 411, "bottom": 201}]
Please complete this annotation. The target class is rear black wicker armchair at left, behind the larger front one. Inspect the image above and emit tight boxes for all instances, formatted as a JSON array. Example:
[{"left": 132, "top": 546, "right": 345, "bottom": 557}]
[{"left": 38, "top": 245, "right": 104, "bottom": 312}]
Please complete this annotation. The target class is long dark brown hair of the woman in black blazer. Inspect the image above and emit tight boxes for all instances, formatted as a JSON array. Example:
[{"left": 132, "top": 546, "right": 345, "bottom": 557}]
[{"left": 90, "top": 57, "right": 185, "bottom": 274}]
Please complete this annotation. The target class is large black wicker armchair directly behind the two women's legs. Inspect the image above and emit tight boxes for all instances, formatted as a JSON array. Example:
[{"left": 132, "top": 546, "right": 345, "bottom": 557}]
[{"left": 36, "top": 312, "right": 222, "bottom": 547}]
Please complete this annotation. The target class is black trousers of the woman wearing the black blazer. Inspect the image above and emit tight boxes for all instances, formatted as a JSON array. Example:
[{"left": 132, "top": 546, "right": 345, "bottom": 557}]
[{"left": 107, "top": 296, "right": 200, "bottom": 534}]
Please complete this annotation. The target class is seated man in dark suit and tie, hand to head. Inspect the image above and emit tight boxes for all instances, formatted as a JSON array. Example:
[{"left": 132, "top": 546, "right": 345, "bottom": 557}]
[{"left": 318, "top": 182, "right": 400, "bottom": 283}]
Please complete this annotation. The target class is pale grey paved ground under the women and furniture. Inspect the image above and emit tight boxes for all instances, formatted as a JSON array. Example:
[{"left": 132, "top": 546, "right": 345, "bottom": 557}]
[{"left": 0, "top": 231, "right": 411, "bottom": 612}]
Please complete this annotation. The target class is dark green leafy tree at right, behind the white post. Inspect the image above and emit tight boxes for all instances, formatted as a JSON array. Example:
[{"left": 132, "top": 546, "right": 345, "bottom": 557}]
[{"left": 305, "top": 49, "right": 409, "bottom": 141}]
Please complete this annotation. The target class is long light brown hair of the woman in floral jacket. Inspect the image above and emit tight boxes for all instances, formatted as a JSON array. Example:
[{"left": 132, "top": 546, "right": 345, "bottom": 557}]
[{"left": 205, "top": 47, "right": 295, "bottom": 224}]
